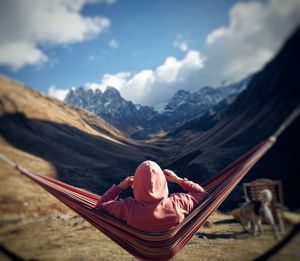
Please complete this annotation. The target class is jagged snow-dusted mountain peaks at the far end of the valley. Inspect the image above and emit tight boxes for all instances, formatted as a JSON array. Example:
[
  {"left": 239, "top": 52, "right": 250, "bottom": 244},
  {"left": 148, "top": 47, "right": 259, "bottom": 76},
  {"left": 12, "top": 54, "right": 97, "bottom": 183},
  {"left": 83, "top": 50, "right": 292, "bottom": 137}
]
[{"left": 65, "top": 77, "right": 251, "bottom": 138}]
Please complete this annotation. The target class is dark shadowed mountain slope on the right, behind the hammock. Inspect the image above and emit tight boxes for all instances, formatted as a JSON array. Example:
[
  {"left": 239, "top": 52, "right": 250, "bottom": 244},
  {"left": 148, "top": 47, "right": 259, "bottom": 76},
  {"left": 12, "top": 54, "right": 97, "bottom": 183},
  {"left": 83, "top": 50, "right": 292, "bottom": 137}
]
[{"left": 168, "top": 26, "right": 300, "bottom": 207}]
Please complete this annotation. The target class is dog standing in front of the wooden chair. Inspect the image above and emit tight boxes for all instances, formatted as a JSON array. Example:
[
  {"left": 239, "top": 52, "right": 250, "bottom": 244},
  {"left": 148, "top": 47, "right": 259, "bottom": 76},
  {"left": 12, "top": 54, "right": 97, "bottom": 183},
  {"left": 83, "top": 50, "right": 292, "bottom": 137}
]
[{"left": 240, "top": 189, "right": 279, "bottom": 239}]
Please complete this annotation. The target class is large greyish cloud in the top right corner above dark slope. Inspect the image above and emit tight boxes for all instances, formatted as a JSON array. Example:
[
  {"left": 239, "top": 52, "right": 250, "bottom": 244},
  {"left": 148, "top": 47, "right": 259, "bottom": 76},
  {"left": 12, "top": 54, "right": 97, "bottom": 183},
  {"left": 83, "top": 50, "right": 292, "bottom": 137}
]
[{"left": 201, "top": 0, "right": 300, "bottom": 85}]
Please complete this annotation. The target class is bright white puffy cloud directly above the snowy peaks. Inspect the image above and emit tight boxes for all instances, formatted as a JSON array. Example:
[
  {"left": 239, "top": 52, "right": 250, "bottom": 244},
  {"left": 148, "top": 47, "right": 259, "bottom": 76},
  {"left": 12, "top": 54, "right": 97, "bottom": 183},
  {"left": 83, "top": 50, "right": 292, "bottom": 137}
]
[{"left": 86, "top": 51, "right": 204, "bottom": 105}]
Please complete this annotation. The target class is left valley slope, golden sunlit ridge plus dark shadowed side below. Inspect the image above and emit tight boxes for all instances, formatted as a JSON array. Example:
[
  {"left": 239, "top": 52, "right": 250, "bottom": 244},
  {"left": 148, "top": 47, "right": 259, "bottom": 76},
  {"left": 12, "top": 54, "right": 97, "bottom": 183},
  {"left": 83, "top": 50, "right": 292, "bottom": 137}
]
[{"left": 0, "top": 77, "right": 159, "bottom": 193}]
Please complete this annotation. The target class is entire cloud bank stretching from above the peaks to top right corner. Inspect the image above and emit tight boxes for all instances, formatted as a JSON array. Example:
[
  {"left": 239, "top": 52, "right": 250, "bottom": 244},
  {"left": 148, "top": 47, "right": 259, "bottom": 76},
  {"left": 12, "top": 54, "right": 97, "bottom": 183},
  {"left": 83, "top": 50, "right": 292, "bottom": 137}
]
[{"left": 49, "top": 0, "right": 300, "bottom": 106}]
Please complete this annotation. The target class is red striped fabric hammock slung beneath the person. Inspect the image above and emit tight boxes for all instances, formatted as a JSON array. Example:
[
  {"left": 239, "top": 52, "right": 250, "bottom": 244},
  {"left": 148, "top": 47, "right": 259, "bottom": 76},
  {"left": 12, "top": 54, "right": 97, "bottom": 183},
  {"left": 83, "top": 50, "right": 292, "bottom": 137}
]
[{"left": 15, "top": 136, "right": 276, "bottom": 260}]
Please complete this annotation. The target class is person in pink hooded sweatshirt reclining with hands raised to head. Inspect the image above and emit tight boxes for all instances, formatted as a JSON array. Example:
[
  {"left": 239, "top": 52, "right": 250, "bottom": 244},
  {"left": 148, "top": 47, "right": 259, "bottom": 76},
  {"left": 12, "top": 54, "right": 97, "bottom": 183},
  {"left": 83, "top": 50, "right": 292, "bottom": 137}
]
[{"left": 96, "top": 160, "right": 208, "bottom": 232}]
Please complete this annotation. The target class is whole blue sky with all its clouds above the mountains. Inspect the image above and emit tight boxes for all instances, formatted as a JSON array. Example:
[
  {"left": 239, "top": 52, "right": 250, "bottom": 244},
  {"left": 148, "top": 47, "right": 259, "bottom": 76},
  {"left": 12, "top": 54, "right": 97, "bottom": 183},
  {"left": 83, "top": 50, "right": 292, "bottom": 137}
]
[{"left": 0, "top": 0, "right": 300, "bottom": 105}]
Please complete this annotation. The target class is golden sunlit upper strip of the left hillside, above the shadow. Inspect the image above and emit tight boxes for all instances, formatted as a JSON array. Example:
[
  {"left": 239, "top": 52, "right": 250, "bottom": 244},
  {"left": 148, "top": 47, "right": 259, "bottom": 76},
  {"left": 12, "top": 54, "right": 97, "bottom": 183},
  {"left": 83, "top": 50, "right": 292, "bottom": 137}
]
[{"left": 0, "top": 76, "right": 128, "bottom": 143}]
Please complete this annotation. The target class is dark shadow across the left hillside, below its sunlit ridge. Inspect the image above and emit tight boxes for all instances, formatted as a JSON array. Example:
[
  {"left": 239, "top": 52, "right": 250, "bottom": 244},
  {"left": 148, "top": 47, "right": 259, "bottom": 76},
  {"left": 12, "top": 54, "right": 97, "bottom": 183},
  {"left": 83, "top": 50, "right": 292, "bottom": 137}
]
[{"left": 0, "top": 112, "right": 162, "bottom": 193}]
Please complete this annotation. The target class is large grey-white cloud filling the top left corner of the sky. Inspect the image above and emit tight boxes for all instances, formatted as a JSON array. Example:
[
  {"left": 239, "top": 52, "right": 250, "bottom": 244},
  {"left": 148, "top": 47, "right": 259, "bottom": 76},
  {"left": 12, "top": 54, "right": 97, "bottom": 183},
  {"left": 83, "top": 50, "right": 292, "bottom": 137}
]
[{"left": 0, "top": 0, "right": 114, "bottom": 70}]
